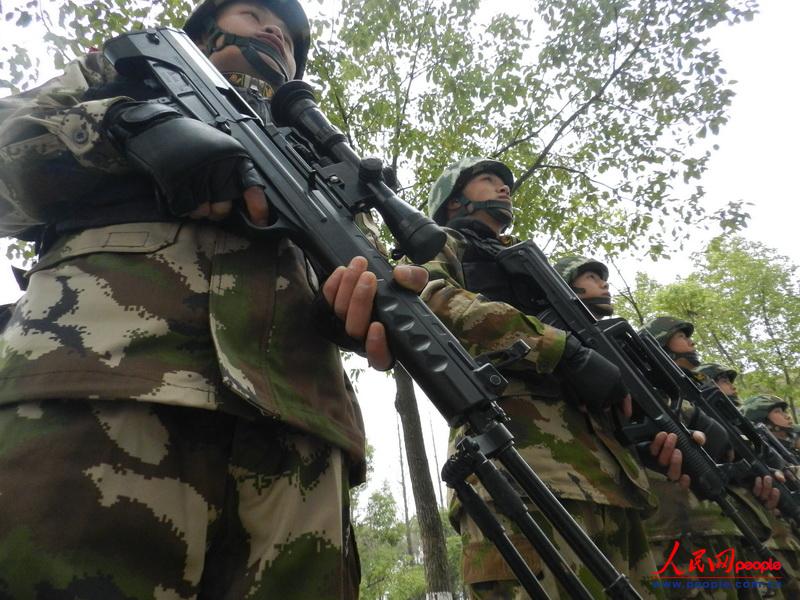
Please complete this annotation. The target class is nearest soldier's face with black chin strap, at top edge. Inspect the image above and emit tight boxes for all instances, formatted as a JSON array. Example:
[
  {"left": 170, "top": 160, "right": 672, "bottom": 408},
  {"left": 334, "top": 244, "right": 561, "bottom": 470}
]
[{"left": 209, "top": 2, "right": 297, "bottom": 79}]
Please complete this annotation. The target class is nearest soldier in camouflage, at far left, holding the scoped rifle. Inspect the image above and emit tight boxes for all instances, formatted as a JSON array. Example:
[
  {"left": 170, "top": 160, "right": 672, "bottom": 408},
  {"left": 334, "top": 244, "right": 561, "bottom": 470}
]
[{"left": 0, "top": 0, "right": 424, "bottom": 599}]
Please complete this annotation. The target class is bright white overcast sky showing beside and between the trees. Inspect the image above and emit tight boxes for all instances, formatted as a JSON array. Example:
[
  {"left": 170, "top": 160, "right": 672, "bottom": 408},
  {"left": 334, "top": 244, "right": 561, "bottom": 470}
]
[{"left": 0, "top": 0, "right": 800, "bottom": 516}]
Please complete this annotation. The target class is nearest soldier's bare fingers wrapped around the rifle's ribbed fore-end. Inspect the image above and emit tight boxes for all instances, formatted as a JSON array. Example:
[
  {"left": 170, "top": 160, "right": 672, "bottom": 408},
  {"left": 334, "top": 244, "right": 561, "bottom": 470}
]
[{"left": 322, "top": 256, "right": 428, "bottom": 371}]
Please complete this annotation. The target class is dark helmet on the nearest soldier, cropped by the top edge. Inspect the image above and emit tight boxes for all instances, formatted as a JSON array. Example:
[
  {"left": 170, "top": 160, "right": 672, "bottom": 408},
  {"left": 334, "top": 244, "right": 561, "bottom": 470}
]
[{"left": 183, "top": 0, "right": 311, "bottom": 79}]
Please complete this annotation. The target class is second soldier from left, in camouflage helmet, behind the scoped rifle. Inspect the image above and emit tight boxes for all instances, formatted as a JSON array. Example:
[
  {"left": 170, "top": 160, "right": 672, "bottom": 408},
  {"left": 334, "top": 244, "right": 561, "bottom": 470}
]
[{"left": 412, "top": 158, "right": 712, "bottom": 598}]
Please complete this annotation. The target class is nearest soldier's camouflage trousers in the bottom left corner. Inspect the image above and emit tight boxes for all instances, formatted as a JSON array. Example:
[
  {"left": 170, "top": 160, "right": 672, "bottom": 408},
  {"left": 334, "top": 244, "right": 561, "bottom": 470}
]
[{"left": 0, "top": 400, "right": 359, "bottom": 600}]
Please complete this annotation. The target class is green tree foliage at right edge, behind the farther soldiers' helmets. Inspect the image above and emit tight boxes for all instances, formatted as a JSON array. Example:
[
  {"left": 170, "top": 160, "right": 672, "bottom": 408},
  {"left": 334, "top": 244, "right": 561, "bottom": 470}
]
[{"left": 619, "top": 236, "right": 800, "bottom": 412}]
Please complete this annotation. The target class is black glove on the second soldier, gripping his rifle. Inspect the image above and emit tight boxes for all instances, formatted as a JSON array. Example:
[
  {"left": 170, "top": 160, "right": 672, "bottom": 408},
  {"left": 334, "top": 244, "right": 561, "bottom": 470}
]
[{"left": 555, "top": 335, "right": 628, "bottom": 411}]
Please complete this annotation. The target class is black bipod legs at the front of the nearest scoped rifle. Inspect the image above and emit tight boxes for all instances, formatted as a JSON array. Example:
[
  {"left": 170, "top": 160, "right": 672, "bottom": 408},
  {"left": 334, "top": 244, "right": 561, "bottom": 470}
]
[{"left": 442, "top": 407, "right": 641, "bottom": 600}]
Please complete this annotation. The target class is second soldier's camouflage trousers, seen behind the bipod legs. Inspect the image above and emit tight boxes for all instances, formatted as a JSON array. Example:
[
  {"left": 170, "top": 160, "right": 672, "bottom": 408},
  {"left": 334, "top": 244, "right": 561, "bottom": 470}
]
[{"left": 460, "top": 500, "right": 663, "bottom": 600}]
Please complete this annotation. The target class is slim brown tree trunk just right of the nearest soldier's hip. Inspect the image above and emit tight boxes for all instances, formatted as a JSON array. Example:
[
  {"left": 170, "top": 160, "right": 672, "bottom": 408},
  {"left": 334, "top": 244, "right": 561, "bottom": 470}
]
[{"left": 394, "top": 365, "right": 453, "bottom": 600}]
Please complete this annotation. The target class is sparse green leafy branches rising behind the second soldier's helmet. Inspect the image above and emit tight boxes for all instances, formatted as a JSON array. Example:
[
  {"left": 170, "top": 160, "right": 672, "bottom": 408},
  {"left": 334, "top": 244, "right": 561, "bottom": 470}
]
[{"left": 312, "top": 0, "right": 756, "bottom": 256}]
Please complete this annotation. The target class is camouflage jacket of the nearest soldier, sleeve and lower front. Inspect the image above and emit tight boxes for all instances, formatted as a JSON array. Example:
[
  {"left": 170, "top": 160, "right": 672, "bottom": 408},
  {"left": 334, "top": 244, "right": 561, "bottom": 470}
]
[{"left": 0, "top": 54, "right": 364, "bottom": 459}]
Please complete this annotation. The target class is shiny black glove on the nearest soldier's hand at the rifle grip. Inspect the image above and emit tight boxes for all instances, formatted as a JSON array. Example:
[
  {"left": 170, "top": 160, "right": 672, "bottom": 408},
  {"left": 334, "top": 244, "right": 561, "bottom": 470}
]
[{"left": 103, "top": 102, "right": 265, "bottom": 216}]
